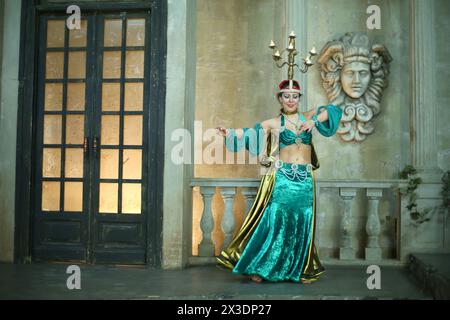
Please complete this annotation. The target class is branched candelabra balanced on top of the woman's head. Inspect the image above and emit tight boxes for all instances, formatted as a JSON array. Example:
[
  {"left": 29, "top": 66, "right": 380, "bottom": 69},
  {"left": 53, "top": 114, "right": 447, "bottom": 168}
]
[{"left": 269, "top": 31, "right": 317, "bottom": 80}]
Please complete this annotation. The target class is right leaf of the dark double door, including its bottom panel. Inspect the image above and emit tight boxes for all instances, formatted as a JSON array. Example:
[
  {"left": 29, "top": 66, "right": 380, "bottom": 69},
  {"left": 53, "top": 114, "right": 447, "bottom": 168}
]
[{"left": 93, "top": 13, "right": 149, "bottom": 263}]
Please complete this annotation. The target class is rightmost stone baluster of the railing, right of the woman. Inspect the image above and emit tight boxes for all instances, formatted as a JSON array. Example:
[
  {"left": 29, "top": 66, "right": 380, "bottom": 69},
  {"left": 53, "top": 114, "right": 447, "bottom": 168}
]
[{"left": 366, "top": 188, "right": 383, "bottom": 260}]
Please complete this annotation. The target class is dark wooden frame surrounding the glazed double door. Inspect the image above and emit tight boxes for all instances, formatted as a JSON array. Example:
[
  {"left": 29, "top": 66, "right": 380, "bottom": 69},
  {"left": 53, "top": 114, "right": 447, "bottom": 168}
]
[{"left": 14, "top": 0, "right": 167, "bottom": 267}]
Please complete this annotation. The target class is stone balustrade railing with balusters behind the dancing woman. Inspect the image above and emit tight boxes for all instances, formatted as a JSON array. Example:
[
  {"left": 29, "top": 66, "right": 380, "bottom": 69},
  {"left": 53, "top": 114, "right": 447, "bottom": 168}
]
[{"left": 190, "top": 179, "right": 406, "bottom": 264}]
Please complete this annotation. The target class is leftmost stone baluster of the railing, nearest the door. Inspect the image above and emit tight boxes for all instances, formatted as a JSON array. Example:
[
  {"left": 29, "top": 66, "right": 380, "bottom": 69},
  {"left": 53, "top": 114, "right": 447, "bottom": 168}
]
[{"left": 198, "top": 187, "right": 216, "bottom": 257}]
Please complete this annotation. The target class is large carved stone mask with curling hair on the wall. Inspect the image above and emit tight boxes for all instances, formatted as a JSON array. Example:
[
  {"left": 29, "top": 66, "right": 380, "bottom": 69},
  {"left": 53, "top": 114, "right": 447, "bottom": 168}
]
[{"left": 318, "top": 33, "right": 392, "bottom": 142}]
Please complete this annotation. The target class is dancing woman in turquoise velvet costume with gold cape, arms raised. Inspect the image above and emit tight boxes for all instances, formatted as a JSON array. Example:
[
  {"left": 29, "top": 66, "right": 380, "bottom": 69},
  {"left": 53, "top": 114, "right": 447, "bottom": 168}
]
[{"left": 217, "top": 80, "right": 342, "bottom": 283}]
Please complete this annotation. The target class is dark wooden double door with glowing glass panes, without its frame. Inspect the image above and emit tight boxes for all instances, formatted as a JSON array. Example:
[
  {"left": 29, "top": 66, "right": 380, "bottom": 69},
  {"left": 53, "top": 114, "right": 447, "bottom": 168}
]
[{"left": 32, "top": 12, "right": 150, "bottom": 264}]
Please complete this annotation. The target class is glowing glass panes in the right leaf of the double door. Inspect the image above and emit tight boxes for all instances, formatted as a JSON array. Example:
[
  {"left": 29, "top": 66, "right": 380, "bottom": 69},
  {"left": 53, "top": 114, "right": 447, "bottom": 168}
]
[{"left": 97, "top": 16, "right": 146, "bottom": 215}]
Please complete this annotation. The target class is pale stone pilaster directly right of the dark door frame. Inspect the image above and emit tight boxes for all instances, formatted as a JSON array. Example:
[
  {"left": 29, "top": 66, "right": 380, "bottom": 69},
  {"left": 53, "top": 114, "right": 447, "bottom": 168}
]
[{"left": 162, "top": 0, "right": 196, "bottom": 269}]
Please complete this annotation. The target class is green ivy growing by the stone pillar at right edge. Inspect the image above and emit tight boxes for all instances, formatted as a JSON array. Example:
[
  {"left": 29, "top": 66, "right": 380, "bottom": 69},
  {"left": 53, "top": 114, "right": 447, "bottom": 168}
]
[{"left": 399, "top": 165, "right": 450, "bottom": 224}]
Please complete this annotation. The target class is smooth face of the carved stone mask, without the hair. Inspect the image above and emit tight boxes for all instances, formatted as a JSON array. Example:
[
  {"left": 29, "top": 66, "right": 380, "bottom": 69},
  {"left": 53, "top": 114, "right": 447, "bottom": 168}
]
[{"left": 341, "top": 61, "right": 371, "bottom": 99}]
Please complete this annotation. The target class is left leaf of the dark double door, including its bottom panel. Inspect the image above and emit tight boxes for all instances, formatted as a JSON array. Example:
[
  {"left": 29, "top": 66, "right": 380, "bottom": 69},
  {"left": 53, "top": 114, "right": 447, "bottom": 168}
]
[{"left": 33, "top": 16, "right": 93, "bottom": 260}]
